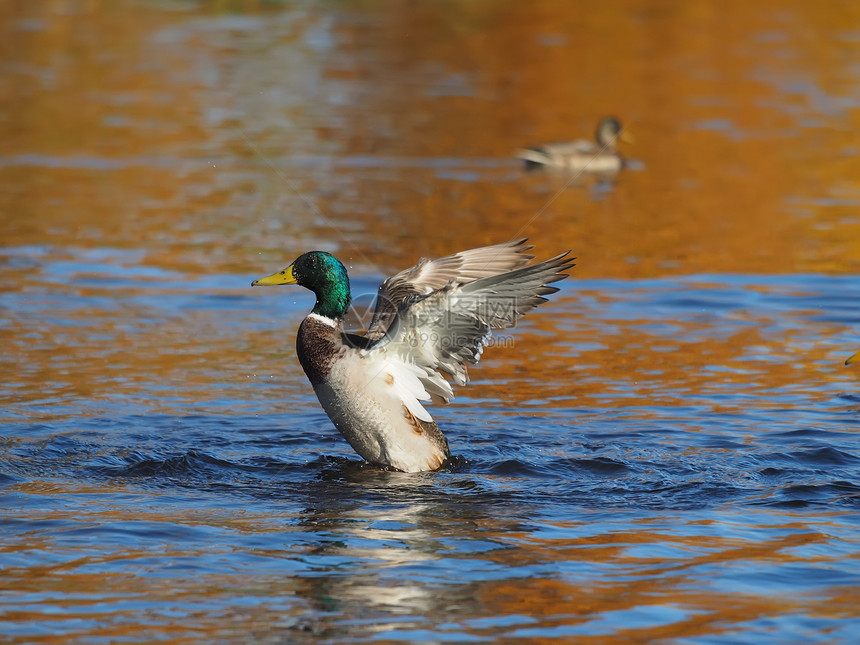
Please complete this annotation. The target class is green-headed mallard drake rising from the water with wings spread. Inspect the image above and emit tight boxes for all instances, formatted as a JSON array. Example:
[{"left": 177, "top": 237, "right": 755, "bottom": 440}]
[{"left": 251, "top": 239, "right": 573, "bottom": 472}]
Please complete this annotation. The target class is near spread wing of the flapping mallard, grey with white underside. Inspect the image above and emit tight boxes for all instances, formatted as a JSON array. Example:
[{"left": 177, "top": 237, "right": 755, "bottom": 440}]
[{"left": 366, "top": 251, "right": 573, "bottom": 402}]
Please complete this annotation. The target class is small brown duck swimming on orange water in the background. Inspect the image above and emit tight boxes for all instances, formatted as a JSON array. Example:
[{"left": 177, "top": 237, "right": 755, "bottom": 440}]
[{"left": 517, "top": 116, "right": 633, "bottom": 174}]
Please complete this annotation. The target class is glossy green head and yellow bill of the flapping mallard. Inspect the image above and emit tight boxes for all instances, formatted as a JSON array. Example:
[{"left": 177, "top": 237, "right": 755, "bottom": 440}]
[{"left": 251, "top": 251, "right": 350, "bottom": 320}]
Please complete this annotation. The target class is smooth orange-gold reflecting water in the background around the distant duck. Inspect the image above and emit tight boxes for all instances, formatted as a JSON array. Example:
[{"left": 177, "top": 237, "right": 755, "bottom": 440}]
[{"left": 5, "top": 1, "right": 860, "bottom": 277}]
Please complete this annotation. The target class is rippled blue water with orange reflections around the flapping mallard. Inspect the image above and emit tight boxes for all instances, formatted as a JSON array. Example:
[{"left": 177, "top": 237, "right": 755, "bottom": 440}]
[{"left": 0, "top": 249, "right": 860, "bottom": 642}]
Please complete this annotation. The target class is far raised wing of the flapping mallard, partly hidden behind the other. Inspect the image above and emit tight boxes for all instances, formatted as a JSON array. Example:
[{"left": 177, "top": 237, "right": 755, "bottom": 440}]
[{"left": 365, "top": 239, "right": 534, "bottom": 340}]
